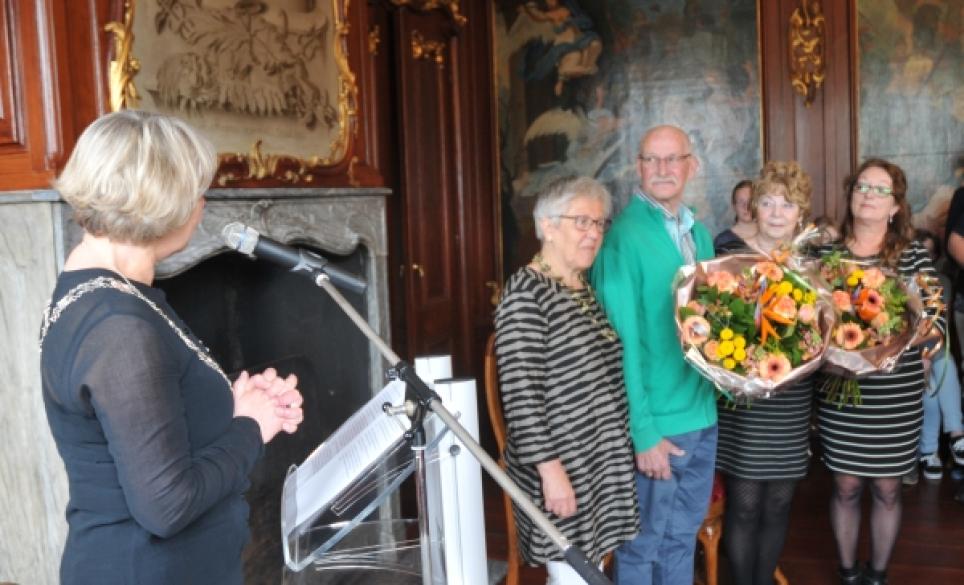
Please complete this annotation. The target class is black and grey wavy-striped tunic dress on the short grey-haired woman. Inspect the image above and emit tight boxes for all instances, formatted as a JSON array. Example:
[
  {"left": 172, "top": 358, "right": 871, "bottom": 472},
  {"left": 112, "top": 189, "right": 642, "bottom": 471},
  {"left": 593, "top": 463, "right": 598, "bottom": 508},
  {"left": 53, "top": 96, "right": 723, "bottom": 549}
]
[{"left": 495, "top": 267, "right": 639, "bottom": 565}]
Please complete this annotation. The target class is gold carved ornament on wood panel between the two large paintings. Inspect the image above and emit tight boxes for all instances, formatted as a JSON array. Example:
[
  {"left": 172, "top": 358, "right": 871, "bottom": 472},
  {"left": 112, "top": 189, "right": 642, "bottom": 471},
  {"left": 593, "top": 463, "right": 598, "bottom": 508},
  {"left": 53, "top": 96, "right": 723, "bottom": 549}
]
[{"left": 789, "top": 0, "right": 827, "bottom": 107}]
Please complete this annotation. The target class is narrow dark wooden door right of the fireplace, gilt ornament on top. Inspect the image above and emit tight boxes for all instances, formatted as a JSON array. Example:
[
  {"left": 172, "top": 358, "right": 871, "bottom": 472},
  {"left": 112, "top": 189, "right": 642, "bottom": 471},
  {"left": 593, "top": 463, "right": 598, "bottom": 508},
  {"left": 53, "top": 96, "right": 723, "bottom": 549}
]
[{"left": 396, "top": 10, "right": 459, "bottom": 356}]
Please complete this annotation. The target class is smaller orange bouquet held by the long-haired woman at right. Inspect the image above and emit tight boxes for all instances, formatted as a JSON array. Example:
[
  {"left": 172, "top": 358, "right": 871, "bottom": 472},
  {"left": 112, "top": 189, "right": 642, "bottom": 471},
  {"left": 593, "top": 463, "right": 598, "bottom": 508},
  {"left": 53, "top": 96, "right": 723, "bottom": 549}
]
[{"left": 819, "top": 252, "right": 941, "bottom": 405}]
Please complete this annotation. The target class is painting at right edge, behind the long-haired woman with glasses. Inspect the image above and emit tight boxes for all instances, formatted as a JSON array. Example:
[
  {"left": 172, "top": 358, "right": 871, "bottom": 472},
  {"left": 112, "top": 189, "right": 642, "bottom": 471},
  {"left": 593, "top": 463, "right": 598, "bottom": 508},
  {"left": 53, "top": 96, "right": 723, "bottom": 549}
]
[{"left": 857, "top": 0, "right": 964, "bottom": 233}]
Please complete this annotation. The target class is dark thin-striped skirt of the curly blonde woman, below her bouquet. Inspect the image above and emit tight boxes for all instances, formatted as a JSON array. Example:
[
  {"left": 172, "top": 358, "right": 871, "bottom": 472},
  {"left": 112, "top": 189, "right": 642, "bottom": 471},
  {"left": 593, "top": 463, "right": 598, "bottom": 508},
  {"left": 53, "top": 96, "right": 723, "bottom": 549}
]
[{"left": 716, "top": 378, "right": 813, "bottom": 481}]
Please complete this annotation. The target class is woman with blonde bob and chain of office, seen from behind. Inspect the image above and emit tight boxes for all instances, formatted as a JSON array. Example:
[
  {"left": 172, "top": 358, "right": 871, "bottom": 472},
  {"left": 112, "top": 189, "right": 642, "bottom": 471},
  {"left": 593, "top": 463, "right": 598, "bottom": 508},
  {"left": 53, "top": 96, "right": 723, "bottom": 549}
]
[{"left": 40, "top": 111, "right": 303, "bottom": 585}]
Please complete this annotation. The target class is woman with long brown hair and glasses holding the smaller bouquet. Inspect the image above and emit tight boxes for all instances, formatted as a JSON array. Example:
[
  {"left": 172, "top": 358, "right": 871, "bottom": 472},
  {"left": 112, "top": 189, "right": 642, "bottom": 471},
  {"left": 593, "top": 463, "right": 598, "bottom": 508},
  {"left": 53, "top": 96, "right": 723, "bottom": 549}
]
[{"left": 817, "top": 159, "right": 944, "bottom": 585}]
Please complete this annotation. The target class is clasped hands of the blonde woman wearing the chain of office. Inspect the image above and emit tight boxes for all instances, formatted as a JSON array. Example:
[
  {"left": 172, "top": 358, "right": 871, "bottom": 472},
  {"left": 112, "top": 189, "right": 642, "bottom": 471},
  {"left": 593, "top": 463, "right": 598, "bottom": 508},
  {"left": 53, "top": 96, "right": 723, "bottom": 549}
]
[{"left": 231, "top": 368, "right": 304, "bottom": 443}]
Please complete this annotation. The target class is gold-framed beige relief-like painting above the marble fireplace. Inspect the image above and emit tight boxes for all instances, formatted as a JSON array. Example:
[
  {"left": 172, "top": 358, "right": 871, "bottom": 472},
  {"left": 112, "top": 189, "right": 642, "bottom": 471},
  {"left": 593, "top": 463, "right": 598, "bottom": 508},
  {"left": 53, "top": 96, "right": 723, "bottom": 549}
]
[{"left": 108, "top": 0, "right": 354, "bottom": 182}]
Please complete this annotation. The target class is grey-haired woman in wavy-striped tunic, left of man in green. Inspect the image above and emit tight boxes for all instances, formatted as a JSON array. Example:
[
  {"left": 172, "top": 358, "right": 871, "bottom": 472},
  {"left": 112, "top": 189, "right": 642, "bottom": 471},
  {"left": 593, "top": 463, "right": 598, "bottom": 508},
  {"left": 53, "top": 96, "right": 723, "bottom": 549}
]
[{"left": 495, "top": 178, "right": 639, "bottom": 585}]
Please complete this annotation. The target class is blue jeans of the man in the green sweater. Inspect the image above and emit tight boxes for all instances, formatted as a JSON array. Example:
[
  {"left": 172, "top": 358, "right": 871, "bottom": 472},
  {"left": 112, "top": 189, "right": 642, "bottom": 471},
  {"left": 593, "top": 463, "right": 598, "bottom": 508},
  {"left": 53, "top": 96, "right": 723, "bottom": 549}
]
[{"left": 616, "top": 425, "right": 717, "bottom": 585}]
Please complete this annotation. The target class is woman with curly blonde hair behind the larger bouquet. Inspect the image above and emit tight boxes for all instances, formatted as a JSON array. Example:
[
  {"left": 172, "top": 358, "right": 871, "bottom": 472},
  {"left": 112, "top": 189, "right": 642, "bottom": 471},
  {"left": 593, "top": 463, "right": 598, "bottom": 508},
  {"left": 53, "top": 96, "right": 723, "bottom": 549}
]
[{"left": 716, "top": 161, "right": 813, "bottom": 585}]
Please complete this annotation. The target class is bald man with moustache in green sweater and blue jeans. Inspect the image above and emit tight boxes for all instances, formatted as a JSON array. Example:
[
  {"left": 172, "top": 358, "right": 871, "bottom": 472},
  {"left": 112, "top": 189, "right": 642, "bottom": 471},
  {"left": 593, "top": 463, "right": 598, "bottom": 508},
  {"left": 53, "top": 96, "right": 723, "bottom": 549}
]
[{"left": 591, "top": 126, "right": 716, "bottom": 585}]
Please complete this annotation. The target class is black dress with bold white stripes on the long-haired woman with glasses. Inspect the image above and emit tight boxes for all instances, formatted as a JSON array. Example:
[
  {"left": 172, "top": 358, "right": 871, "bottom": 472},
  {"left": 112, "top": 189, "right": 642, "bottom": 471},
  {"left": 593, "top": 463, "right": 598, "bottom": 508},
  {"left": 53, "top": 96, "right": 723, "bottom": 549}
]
[{"left": 817, "top": 241, "right": 945, "bottom": 477}]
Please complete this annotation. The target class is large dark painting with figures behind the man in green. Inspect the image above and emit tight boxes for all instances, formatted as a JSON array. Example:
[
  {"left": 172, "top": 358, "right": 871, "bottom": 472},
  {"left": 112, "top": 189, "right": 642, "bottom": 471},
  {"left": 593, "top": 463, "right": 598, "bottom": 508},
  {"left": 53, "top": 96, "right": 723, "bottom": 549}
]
[{"left": 494, "top": 0, "right": 762, "bottom": 273}]
